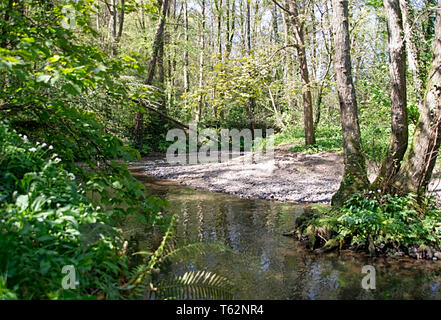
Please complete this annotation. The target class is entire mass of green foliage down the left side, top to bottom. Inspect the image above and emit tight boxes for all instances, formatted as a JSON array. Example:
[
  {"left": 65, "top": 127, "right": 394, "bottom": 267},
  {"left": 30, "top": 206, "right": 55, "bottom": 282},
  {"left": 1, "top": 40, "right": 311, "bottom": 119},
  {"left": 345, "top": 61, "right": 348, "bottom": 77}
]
[{"left": 0, "top": 0, "right": 174, "bottom": 299}]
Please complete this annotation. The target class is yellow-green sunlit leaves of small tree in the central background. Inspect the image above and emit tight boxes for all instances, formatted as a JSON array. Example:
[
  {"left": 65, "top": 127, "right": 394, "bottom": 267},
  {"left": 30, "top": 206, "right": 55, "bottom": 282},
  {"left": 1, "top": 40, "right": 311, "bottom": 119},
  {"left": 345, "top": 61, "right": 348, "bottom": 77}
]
[{"left": 183, "top": 53, "right": 280, "bottom": 129}]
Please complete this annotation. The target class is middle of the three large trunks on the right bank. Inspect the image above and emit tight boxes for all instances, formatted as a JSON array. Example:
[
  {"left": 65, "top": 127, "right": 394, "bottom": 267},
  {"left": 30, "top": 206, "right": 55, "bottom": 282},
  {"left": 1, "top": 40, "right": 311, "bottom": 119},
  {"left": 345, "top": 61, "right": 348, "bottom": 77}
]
[{"left": 374, "top": 0, "right": 409, "bottom": 191}]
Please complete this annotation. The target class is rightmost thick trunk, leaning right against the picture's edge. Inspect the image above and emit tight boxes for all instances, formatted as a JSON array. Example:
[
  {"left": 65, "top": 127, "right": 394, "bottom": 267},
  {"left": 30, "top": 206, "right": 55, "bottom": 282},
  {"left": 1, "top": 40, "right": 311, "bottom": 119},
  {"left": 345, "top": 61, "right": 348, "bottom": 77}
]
[{"left": 393, "top": 10, "right": 441, "bottom": 197}]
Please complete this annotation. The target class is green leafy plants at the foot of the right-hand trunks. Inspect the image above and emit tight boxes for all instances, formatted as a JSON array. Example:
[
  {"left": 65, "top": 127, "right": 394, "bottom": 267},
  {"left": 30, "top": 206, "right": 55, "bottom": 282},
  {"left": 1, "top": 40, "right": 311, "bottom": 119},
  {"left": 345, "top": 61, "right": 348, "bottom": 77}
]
[{"left": 327, "top": 193, "right": 441, "bottom": 248}]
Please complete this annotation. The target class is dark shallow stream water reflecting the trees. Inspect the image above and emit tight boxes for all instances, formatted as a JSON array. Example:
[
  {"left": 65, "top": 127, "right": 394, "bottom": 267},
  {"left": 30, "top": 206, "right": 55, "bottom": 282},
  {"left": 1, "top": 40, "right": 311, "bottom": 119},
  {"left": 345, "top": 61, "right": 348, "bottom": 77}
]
[{"left": 126, "top": 168, "right": 441, "bottom": 299}]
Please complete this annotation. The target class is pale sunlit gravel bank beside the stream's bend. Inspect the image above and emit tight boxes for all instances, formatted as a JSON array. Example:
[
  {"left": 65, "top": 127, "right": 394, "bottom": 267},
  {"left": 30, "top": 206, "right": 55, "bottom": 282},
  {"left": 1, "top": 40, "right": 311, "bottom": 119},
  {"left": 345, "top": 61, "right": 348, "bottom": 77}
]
[{"left": 132, "top": 145, "right": 441, "bottom": 203}]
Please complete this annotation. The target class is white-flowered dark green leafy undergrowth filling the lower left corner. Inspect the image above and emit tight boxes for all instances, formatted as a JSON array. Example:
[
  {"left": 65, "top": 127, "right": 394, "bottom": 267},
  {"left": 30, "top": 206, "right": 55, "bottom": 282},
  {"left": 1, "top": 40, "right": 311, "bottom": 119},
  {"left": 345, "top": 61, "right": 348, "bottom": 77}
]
[{"left": 0, "top": 122, "right": 169, "bottom": 299}]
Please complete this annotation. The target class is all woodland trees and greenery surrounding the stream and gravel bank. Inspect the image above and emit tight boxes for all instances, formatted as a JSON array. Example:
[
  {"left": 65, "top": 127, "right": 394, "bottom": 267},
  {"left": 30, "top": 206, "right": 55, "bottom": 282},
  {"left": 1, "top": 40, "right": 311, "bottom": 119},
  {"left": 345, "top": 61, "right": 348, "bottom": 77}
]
[{"left": 0, "top": 0, "right": 441, "bottom": 299}]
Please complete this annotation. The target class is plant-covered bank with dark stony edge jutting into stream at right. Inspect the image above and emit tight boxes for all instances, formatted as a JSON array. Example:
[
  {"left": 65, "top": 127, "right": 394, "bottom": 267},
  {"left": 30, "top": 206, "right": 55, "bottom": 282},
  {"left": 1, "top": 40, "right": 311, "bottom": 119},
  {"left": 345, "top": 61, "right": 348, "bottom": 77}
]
[{"left": 296, "top": 192, "right": 441, "bottom": 254}]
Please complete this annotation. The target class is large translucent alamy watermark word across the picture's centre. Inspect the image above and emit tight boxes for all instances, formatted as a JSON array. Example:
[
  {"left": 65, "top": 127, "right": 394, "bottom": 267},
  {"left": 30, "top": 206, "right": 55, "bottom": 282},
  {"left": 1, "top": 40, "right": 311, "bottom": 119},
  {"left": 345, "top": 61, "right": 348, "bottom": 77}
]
[{"left": 166, "top": 122, "right": 274, "bottom": 164}]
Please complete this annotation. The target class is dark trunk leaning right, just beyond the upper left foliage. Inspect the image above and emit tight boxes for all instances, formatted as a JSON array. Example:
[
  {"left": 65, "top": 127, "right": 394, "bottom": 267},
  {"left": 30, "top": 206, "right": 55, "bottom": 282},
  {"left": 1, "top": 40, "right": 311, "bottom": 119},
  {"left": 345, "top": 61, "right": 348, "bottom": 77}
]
[{"left": 135, "top": 0, "right": 169, "bottom": 151}]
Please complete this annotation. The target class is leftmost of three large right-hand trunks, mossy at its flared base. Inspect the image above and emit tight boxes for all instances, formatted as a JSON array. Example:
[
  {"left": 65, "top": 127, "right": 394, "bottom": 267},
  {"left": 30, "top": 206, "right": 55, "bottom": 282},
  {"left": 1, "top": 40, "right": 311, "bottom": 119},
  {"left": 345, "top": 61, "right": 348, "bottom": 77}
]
[{"left": 332, "top": 0, "right": 369, "bottom": 206}]
